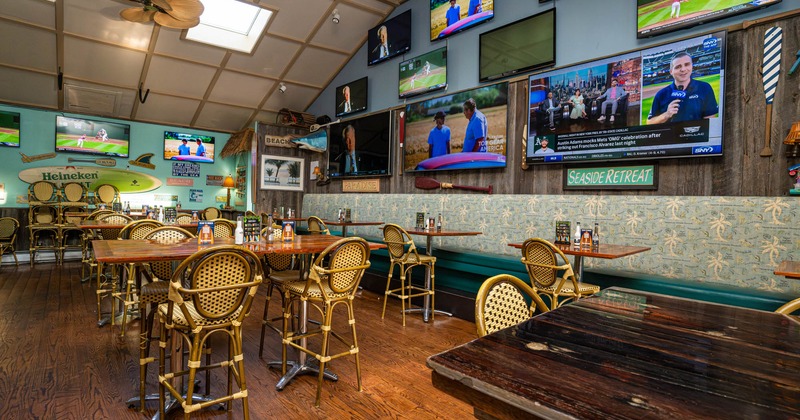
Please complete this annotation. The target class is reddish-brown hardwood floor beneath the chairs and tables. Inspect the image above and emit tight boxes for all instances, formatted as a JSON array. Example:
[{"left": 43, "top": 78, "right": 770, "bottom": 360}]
[{"left": 0, "top": 262, "right": 475, "bottom": 419}]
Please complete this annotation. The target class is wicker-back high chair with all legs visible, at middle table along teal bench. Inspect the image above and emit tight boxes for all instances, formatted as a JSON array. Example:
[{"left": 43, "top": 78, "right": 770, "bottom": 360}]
[{"left": 381, "top": 223, "right": 436, "bottom": 327}]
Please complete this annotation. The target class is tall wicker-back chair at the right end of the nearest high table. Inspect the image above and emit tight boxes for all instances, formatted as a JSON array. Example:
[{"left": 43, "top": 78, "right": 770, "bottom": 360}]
[{"left": 281, "top": 237, "right": 370, "bottom": 406}]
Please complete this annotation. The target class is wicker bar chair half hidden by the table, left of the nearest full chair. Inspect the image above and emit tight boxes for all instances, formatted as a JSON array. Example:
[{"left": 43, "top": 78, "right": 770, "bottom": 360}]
[{"left": 128, "top": 228, "right": 195, "bottom": 411}]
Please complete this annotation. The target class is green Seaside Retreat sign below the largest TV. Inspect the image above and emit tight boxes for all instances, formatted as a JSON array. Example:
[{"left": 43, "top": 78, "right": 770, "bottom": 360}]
[{"left": 564, "top": 164, "right": 658, "bottom": 190}]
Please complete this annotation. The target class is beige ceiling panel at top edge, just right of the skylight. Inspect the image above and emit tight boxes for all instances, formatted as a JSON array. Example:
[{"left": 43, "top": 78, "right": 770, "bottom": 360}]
[{"left": 259, "top": 0, "right": 333, "bottom": 41}]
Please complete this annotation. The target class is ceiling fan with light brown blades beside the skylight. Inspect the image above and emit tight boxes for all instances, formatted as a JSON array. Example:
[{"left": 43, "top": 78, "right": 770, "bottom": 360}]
[{"left": 119, "top": 0, "right": 205, "bottom": 29}]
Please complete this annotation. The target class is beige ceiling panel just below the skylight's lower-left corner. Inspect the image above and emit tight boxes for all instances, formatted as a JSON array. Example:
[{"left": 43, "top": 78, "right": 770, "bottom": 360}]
[{"left": 145, "top": 57, "right": 217, "bottom": 99}]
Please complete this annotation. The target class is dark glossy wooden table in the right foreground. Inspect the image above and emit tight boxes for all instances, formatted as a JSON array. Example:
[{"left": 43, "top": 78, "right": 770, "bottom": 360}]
[{"left": 428, "top": 287, "right": 800, "bottom": 419}]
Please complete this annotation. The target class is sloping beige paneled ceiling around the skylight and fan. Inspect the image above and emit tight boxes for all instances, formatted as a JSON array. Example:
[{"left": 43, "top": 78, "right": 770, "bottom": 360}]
[{"left": 0, "top": 0, "right": 405, "bottom": 131}]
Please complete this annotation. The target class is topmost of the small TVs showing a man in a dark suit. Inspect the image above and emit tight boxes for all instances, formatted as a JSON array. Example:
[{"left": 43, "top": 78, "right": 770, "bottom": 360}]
[{"left": 367, "top": 10, "right": 411, "bottom": 66}]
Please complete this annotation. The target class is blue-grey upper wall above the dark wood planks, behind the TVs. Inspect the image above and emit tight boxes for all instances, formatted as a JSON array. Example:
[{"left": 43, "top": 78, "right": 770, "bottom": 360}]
[{"left": 308, "top": 0, "right": 800, "bottom": 117}]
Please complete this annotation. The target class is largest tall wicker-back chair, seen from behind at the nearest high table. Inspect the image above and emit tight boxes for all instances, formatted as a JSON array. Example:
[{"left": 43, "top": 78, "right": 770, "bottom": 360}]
[{"left": 158, "top": 245, "right": 262, "bottom": 419}]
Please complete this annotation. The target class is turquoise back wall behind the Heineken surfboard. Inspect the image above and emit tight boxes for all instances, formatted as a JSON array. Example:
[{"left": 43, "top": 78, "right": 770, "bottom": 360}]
[{"left": 0, "top": 105, "right": 236, "bottom": 209}]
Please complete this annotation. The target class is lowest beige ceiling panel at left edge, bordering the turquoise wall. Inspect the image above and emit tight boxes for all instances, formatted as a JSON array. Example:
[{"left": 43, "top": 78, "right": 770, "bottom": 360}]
[{"left": 0, "top": 67, "right": 58, "bottom": 108}]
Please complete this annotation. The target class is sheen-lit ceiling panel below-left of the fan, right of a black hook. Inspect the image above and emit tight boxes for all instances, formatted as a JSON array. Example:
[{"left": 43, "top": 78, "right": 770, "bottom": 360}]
[{"left": 64, "top": 36, "right": 145, "bottom": 87}]
